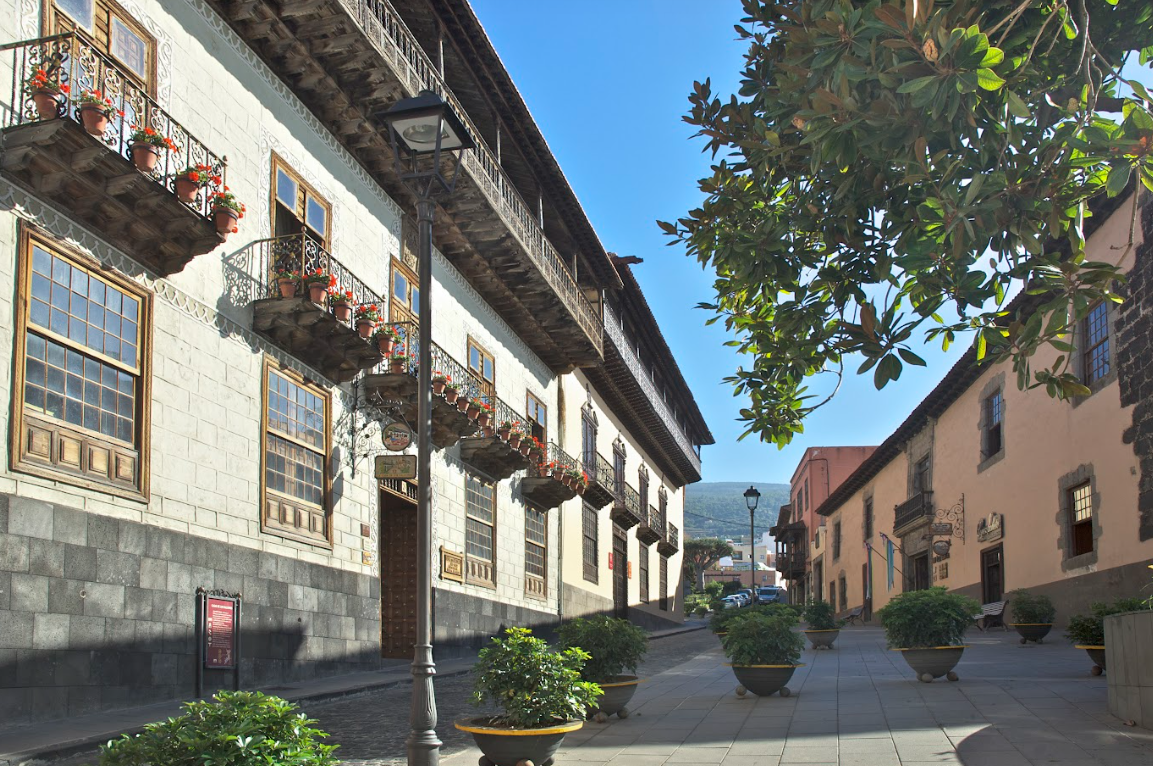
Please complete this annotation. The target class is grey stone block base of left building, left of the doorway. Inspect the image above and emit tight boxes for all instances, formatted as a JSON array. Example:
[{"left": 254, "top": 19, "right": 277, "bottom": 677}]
[{"left": 0, "top": 495, "right": 382, "bottom": 723}]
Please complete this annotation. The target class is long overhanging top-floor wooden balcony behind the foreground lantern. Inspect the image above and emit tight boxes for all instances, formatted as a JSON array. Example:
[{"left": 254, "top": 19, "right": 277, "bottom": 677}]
[{"left": 201, "top": 0, "right": 603, "bottom": 371}]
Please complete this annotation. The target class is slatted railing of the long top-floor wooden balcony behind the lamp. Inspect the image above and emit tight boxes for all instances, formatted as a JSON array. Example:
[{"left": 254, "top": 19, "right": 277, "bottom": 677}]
[{"left": 340, "top": 0, "right": 603, "bottom": 351}]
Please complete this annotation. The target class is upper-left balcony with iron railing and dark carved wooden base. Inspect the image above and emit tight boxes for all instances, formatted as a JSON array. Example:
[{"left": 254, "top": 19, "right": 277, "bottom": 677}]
[{"left": 0, "top": 33, "right": 225, "bottom": 277}]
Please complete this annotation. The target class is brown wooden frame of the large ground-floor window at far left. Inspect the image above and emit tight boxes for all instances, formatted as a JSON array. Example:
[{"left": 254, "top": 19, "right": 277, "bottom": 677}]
[{"left": 8, "top": 225, "right": 152, "bottom": 502}]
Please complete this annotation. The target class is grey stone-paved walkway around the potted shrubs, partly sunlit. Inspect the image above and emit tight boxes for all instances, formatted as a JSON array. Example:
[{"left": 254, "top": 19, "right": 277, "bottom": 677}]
[{"left": 442, "top": 628, "right": 1153, "bottom": 766}]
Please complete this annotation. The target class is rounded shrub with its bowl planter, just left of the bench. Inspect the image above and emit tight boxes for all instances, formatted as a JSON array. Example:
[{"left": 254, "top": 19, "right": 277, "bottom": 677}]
[{"left": 877, "top": 586, "right": 981, "bottom": 683}]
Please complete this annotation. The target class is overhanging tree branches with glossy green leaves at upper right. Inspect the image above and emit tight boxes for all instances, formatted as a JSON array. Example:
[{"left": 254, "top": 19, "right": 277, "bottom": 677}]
[{"left": 658, "top": 0, "right": 1153, "bottom": 446}]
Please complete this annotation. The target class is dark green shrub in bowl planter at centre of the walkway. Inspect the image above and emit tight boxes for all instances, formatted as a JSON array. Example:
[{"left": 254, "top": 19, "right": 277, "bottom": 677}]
[{"left": 721, "top": 611, "right": 805, "bottom": 697}]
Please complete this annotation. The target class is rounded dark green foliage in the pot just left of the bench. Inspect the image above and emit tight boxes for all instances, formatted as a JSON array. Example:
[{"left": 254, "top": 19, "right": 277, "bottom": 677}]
[{"left": 877, "top": 587, "right": 981, "bottom": 648}]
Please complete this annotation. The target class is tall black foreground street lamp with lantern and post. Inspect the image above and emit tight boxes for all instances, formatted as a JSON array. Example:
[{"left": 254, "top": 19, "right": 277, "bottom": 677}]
[{"left": 378, "top": 90, "right": 476, "bottom": 766}]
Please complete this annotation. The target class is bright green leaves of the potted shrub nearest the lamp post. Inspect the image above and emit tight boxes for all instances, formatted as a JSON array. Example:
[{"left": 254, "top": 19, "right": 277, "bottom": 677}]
[{"left": 472, "top": 628, "right": 604, "bottom": 729}]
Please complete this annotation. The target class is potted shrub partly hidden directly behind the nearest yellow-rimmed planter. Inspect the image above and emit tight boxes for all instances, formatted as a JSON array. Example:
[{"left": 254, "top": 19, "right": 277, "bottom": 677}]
[{"left": 557, "top": 615, "right": 648, "bottom": 723}]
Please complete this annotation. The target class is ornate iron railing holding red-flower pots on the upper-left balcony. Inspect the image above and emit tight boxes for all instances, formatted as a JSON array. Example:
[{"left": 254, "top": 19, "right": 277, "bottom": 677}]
[{"left": 0, "top": 32, "right": 227, "bottom": 218}]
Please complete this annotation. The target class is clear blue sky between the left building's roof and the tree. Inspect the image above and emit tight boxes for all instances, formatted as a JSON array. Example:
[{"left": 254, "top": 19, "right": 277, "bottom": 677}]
[{"left": 472, "top": 0, "right": 1150, "bottom": 483}]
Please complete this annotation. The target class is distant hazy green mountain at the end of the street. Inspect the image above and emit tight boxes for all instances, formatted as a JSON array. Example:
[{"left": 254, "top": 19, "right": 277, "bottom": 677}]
[{"left": 685, "top": 481, "right": 789, "bottom": 538}]
